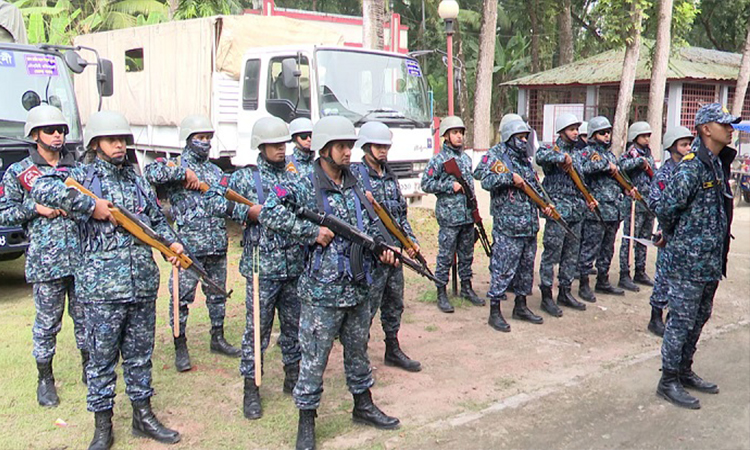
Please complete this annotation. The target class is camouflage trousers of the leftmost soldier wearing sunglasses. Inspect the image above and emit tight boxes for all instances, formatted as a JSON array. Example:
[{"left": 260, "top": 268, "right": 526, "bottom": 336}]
[{"left": 31, "top": 277, "right": 86, "bottom": 361}]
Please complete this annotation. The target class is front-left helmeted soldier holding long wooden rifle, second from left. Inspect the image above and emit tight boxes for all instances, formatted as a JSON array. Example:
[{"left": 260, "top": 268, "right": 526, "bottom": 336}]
[{"left": 32, "top": 111, "right": 183, "bottom": 450}]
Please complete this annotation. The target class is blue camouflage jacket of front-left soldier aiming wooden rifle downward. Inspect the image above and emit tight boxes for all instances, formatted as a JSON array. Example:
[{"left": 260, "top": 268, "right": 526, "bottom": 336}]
[{"left": 31, "top": 158, "right": 174, "bottom": 303}]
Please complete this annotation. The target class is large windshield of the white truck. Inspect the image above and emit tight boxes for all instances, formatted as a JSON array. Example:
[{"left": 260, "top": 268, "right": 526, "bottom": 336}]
[{"left": 316, "top": 49, "right": 431, "bottom": 127}]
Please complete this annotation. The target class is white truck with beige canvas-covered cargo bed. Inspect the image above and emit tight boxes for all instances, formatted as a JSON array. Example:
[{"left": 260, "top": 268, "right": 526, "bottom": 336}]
[{"left": 75, "top": 15, "right": 434, "bottom": 199}]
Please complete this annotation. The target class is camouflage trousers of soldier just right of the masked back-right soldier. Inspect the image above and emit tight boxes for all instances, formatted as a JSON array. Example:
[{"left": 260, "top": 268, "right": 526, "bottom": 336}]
[{"left": 539, "top": 219, "right": 583, "bottom": 287}]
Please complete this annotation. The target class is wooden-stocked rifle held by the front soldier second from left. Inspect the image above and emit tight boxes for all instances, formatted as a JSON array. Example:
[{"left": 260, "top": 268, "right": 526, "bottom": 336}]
[{"left": 65, "top": 178, "right": 232, "bottom": 298}]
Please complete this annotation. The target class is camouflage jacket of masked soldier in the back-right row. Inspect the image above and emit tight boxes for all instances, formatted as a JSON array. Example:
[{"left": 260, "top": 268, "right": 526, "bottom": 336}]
[{"left": 474, "top": 143, "right": 540, "bottom": 237}]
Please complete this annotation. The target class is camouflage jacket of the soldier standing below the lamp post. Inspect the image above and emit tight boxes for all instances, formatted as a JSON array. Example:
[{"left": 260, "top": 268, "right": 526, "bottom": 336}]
[{"left": 422, "top": 143, "right": 474, "bottom": 227}]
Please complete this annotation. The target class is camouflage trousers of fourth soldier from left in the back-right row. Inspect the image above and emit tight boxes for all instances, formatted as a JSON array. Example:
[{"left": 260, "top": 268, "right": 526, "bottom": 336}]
[{"left": 578, "top": 220, "right": 620, "bottom": 276}]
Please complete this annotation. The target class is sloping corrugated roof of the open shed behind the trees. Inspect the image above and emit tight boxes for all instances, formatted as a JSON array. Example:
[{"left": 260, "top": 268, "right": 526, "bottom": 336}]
[{"left": 503, "top": 43, "right": 742, "bottom": 86}]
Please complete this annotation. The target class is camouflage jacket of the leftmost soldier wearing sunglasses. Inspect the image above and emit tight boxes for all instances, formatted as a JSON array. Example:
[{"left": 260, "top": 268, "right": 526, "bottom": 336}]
[{"left": 0, "top": 148, "right": 80, "bottom": 283}]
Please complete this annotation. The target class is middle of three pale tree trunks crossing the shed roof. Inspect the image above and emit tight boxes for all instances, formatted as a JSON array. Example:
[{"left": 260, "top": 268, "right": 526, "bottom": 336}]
[{"left": 648, "top": 0, "right": 673, "bottom": 156}]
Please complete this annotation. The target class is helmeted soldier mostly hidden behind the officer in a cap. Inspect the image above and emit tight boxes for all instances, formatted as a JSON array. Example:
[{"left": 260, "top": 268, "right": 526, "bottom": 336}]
[{"left": 648, "top": 127, "right": 693, "bottom": 337}]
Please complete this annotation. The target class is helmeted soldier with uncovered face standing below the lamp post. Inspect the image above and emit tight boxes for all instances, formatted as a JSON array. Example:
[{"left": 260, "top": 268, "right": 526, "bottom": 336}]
[{"left": 422, "top": 116, "right": 485, "bottom": 313}]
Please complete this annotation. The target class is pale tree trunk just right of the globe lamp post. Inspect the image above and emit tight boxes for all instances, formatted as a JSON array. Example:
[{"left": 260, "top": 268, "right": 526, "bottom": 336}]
[{"left": 474, "top": 0, "right": 497, "bottom": 150}]
